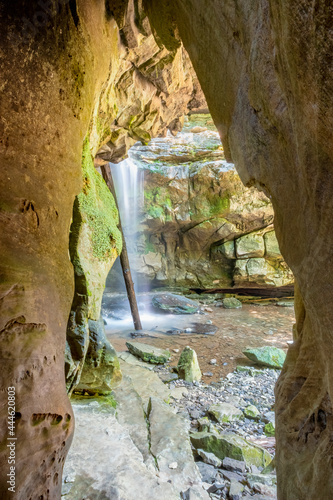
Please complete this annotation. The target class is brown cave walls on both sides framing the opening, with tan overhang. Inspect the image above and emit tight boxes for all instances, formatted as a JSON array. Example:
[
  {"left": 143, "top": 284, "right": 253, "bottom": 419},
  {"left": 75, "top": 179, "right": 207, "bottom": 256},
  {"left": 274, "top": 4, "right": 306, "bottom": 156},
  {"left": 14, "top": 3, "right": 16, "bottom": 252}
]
[{"left": 0, "top": 0, "right": 333, "bottom": 500}]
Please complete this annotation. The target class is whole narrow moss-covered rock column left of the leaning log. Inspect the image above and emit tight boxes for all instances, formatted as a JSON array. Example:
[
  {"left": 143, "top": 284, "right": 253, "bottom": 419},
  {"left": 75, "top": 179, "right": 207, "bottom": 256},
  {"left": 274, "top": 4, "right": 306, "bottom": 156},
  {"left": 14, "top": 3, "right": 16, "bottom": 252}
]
[{"left": 66, "top": 140, "right": 122, "bottom": 392}]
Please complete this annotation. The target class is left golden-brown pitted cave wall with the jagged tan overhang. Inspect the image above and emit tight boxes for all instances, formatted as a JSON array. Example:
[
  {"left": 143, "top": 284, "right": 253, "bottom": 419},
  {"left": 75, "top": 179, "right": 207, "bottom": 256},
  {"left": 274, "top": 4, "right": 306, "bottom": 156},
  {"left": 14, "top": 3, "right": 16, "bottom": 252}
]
[{"left": 0, "top": 0, "right": 202, "bottom": 500}]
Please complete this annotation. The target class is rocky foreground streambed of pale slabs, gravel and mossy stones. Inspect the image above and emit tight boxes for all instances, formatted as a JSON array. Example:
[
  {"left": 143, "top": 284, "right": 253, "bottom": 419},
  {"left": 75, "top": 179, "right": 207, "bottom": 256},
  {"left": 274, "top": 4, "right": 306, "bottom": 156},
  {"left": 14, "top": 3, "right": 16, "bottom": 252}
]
[{"left": 63, "top": 308, "right": 288, "bottom": 500}]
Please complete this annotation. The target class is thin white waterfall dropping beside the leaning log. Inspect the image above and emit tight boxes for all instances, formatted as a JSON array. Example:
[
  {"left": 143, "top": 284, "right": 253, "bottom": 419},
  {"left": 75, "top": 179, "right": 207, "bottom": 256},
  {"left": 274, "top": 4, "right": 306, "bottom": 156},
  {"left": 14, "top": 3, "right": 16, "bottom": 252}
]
[{"left": 110, "top": 158, "right": 144, "bottom": 292}]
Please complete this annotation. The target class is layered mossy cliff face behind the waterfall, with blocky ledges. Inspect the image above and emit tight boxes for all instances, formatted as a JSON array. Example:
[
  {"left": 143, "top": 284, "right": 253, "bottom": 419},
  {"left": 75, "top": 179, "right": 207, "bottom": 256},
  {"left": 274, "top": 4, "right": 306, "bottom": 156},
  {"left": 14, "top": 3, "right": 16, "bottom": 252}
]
[{"left": 107, "top": 114, "right": 293, "bottom": 289}]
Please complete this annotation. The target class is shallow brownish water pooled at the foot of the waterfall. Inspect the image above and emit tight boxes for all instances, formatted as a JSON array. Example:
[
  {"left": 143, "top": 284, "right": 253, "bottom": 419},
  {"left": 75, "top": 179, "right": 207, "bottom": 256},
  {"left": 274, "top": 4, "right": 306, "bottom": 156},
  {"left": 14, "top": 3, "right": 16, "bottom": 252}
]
[{"left": 103, "top": 293, "right": 295, "bottom": 383}]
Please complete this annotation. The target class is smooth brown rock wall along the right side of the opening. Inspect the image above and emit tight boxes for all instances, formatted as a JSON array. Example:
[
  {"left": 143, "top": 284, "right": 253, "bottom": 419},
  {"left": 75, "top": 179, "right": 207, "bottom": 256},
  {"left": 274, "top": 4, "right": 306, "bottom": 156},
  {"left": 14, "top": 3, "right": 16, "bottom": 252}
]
[{"left": 147, "top": 0, "right": 333, "bottom": 500}]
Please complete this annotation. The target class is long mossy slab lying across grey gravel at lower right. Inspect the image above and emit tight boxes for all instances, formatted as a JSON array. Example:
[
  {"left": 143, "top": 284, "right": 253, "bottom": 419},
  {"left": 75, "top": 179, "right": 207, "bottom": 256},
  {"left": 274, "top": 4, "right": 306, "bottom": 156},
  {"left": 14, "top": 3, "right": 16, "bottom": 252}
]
[{"left": 190, "top": 432, "right": 272, "bottom": 467}]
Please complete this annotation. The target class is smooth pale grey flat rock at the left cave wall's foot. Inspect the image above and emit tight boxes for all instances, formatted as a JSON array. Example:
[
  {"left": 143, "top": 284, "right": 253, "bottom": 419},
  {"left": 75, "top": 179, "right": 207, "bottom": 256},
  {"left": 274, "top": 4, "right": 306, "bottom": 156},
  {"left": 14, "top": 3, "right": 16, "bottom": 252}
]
[{"left": 59, "top": 398, "right": 179, "bottom": 500}]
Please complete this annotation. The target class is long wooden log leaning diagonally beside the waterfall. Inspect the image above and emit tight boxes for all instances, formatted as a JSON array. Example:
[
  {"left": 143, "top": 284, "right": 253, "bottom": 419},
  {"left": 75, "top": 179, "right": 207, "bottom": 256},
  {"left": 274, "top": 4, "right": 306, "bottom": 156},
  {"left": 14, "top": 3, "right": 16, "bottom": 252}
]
[{"left": 101, "top": 164, "right": 142, "bottom": 330}]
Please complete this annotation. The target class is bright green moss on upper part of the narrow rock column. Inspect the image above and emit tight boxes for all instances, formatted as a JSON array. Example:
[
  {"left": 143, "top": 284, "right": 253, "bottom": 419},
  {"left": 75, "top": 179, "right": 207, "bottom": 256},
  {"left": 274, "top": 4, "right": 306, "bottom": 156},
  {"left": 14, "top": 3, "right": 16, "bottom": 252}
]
[{"left": 77, "top": 139, "right": 122, "bottom": 260}]
